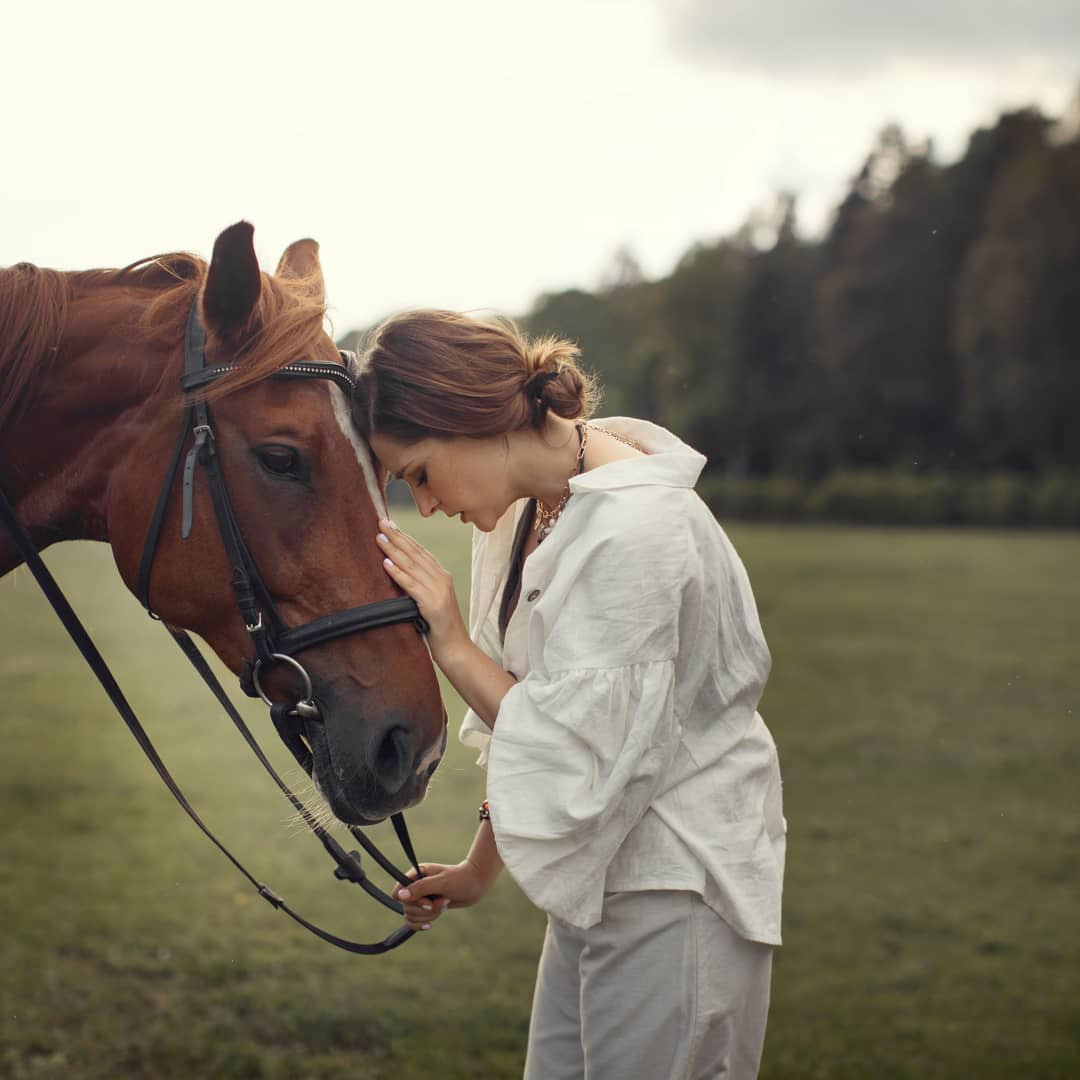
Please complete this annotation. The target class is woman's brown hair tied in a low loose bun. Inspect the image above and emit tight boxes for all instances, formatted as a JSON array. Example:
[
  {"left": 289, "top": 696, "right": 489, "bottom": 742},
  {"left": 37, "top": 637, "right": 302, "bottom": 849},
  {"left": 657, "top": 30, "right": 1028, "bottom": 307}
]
[{"left": 354, "top": 310, "right": 597, "bottom": 442}]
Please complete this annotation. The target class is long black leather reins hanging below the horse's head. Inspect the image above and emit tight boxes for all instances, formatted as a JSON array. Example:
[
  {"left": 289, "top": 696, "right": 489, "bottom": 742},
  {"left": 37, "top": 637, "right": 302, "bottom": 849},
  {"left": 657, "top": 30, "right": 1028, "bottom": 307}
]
[{"left": 0, "top": 490, "right": 413, "bottom": 956}]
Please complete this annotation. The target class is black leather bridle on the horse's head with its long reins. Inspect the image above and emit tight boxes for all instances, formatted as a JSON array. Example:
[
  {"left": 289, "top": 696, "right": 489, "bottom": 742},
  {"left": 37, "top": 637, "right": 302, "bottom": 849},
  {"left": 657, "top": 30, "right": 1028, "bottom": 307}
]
[{"left": 0, "top": 300, "right": 436, "bottom": 955}]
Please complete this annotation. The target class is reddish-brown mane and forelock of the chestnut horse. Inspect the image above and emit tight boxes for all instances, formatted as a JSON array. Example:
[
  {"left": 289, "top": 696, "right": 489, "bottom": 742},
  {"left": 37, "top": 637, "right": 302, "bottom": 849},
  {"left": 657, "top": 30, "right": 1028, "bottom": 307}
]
[{"left": 0, "top": 252, "right": 326, "bottom": 431}]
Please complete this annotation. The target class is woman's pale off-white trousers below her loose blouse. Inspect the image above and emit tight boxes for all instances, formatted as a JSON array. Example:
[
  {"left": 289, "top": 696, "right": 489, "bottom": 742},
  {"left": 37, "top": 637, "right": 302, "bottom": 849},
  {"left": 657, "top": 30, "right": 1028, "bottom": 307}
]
[{"left": 525, "top": 892, "right": 772, "bottom": 1080}]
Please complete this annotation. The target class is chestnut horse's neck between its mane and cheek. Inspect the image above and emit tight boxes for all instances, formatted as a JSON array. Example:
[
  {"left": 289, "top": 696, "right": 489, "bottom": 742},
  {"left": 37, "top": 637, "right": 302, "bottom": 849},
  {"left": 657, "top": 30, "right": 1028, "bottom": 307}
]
[{"left": 0, "top": 275, "right": 179, "bottom": 573}]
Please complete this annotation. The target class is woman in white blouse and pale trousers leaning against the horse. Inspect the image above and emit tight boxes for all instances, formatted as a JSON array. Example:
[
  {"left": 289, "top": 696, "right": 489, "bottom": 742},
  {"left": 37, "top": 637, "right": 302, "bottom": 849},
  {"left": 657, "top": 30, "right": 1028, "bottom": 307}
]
[{"left": 356, "top": 311, "right": 784, "bottom": 1080}]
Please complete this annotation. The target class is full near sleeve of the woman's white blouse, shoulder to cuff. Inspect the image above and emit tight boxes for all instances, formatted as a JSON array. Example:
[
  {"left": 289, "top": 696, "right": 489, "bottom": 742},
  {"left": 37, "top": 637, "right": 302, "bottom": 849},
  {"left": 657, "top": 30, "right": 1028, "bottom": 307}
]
[{"left": 487, "top": 503, "right": 685, "bottom": 928}]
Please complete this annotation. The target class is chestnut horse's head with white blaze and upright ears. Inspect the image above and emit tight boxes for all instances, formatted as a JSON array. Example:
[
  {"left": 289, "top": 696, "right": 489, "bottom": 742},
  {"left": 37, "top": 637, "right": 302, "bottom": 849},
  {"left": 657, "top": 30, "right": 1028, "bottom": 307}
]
[{"left": 104, "top": 222, "right": 446, "bottom": 824}]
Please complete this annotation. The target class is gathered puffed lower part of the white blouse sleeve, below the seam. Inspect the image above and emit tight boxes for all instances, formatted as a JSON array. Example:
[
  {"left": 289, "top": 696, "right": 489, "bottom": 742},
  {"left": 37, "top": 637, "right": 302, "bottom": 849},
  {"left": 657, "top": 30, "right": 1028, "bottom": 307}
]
[{"left": 487, "top": 661, "right": 678, "bottom": 928}]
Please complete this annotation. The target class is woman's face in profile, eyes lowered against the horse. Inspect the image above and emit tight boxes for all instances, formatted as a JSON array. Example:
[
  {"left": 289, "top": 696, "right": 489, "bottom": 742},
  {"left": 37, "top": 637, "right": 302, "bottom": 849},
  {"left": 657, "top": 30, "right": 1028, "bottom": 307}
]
[{"left": 370, "top": 435, "right": 517, "bottom": 532}]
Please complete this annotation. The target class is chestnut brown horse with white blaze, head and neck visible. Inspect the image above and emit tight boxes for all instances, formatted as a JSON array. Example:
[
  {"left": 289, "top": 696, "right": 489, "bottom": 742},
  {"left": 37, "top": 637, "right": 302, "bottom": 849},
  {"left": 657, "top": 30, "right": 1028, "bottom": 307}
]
[{"left": 0, "top": 222, "right": 446, "bottom": 824}]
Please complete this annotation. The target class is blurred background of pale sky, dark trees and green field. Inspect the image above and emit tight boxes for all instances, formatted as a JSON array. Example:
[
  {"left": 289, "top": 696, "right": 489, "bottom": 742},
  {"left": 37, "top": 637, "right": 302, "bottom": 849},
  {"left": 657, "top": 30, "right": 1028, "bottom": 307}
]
[{"left": 0, "top": 0, "right": 1080, "bottom": 1078}]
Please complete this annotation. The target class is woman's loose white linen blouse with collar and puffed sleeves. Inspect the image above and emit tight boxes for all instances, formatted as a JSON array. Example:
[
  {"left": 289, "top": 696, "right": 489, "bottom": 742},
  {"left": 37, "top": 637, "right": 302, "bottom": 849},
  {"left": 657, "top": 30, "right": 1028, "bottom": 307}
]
[{"left": 460, "top": 417, "right": 785, "bottom": 945}]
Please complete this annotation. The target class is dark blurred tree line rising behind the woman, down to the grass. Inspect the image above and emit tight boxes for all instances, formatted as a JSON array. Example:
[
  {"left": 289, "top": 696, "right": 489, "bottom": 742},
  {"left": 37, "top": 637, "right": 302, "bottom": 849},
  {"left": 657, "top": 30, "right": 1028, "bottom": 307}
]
[{"left": 345, "top": 98, "right": 1080, "bottom": 525}]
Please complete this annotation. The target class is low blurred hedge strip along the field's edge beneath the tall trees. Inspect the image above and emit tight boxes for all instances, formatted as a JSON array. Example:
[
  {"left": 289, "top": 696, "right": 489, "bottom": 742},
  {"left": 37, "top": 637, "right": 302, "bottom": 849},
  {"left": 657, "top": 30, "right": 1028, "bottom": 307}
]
[{"left": 698, "top": 470, "right": 1080, "bottom": 528}]
